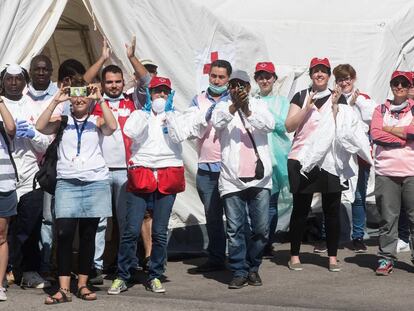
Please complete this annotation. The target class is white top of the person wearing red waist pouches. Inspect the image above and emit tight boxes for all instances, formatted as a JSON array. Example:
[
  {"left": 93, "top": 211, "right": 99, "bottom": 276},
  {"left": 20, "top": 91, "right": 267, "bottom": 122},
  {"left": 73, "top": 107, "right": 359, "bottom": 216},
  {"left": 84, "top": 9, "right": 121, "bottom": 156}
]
[{"left": 124, "top": 110, "right": 183, "bottom": 168}]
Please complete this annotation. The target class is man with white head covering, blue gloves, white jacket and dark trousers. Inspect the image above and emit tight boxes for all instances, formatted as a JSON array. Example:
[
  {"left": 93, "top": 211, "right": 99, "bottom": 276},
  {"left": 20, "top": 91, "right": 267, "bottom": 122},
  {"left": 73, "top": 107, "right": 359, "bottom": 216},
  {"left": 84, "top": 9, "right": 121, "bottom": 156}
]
[{"left": 0, "top": 64, "right": 50, "bottom": 288}]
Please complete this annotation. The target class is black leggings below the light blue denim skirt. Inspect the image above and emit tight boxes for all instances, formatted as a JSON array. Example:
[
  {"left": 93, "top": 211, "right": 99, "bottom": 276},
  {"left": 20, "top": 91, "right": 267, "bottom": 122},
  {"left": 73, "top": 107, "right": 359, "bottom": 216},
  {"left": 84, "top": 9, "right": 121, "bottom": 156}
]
[{"left": 56, "top": 218, "right": 99, "bottom": 276}]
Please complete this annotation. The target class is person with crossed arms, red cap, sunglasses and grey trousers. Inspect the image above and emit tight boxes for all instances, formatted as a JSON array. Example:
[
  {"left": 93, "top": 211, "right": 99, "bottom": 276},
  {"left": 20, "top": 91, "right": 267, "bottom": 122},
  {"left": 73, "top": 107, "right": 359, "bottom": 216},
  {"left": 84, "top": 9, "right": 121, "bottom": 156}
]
[{"left": 371, "top": 71, "right": 414, "bottom": 275}]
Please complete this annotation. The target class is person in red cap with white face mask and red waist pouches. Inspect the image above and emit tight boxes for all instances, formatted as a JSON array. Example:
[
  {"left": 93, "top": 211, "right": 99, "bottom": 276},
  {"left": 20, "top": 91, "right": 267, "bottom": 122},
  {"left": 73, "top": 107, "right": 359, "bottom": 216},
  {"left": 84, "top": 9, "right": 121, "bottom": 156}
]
[{"left": 108, "top": 77, "right": 185, "bottom": 295}]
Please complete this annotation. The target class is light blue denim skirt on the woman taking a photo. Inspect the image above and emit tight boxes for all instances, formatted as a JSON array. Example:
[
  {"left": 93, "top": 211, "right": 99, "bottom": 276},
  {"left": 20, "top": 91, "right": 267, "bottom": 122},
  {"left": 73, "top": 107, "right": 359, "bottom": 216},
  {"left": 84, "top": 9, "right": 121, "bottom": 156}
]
[{"left": 55, "top": 179, "right": 112, "bottom": 218}]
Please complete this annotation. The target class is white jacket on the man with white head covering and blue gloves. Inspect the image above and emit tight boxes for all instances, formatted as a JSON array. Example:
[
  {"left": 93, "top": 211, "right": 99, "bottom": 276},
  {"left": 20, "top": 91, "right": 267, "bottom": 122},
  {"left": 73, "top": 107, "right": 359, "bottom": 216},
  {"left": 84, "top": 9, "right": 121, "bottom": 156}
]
[{"left": 3, "top": 95, "right": 50, "bottom": 198}]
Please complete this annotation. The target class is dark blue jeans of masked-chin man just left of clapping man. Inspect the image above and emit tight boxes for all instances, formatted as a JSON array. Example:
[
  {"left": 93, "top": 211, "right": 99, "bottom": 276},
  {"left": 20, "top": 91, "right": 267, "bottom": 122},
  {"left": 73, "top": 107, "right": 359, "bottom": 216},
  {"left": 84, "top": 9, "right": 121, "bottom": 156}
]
[{"left": 196, "top": 169, "right": 226, "bottom": 265}]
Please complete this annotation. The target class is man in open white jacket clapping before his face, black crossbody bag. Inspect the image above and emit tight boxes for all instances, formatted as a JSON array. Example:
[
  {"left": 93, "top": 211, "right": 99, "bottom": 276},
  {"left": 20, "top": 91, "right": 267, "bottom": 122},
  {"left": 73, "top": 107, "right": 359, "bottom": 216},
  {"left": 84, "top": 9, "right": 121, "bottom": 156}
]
[{"left": 211, "top": 70, "right": 275, "bottom": 289}]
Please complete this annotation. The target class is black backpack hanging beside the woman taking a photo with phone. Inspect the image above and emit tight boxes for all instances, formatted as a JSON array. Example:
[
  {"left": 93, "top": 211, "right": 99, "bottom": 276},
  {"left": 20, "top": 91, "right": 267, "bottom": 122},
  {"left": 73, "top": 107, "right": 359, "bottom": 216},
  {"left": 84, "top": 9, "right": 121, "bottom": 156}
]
[{"left": 33, "top": 116, "right": 68, "bottom": 195}]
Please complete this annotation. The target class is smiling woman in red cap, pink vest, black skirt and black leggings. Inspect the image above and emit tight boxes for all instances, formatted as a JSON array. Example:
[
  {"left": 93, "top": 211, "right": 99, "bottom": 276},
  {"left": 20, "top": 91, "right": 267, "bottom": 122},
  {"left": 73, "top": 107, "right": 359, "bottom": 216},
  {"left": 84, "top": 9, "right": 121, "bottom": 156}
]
[{"left": 285, "top": 58, "right": 347, "bottom": 272}]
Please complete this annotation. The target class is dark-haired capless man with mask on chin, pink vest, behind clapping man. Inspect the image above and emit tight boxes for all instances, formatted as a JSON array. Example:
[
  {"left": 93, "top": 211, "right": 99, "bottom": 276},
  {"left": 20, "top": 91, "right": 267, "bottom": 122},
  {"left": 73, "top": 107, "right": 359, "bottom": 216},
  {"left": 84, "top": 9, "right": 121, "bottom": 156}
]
[{"left": 191, "top": 59, "right": 232, "bottom": 273}]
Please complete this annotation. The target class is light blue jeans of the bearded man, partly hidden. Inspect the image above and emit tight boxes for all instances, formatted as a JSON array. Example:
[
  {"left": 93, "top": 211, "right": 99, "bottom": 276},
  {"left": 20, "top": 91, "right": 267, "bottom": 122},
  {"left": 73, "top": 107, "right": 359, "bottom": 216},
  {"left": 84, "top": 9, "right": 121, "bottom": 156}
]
[{"left": 94, "top": 169, "right": 129, "bottom": 270}]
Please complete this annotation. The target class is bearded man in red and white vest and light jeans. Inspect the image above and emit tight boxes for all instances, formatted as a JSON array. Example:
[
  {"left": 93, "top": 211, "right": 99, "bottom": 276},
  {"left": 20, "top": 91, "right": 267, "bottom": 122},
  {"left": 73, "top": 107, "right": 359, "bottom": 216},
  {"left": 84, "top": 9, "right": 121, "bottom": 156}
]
[{"left": 89, "top": 65, "right": 138, "bottom": 285}]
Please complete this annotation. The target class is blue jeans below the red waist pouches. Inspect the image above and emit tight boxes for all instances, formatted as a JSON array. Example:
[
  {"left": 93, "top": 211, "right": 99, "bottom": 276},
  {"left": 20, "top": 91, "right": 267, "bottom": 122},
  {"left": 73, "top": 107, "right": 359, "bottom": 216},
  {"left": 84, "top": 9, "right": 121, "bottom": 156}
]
[{"left": 118, "top": 191, "right": 176, "bottom": 281}]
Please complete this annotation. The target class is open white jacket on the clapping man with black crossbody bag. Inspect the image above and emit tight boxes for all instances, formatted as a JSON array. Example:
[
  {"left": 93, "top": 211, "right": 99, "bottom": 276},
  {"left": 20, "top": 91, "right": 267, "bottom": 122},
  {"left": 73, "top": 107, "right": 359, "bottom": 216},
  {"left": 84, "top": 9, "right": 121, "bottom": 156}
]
[{"left": 211, "top": 97, "right": 275, "bottom": 196}]
